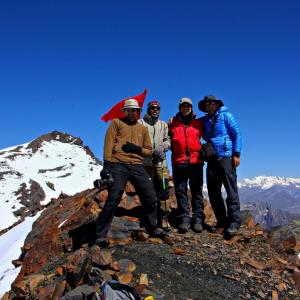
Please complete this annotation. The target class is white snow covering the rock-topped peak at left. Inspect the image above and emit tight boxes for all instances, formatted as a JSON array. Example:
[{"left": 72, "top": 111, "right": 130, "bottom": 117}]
[{"left": 0, "top": 140, "right": 101, "bottom": 230}]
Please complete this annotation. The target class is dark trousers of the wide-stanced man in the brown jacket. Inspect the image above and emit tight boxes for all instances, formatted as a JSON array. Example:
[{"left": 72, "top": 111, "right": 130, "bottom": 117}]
[{"left": 97, "top": 163, "right": 157, "bottom": 238}]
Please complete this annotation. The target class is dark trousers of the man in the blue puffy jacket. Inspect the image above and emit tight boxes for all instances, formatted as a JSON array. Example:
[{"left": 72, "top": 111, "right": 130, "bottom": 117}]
[{"left": 206, "top": 157, "right": 241, "bottom": 227}]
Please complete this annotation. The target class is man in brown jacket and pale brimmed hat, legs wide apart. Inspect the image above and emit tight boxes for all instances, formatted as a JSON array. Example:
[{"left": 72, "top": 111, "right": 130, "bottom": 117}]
[{"left": 96, "top": 99, "right": 165, "bottom": 247}]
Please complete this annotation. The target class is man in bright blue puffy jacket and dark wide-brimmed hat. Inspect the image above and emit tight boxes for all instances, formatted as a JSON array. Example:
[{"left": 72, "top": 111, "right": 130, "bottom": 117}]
[{"left": 198, "top": 95, "right": 242, "bottom": 236}]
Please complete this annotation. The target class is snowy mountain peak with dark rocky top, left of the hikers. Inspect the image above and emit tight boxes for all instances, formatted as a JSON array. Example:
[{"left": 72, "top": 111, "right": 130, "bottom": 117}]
[{"left": 0, "top": 131, "right": 101, "bottom": 230}]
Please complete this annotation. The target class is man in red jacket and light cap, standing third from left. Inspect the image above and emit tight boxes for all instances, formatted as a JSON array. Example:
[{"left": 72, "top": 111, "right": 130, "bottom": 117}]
[{"left": 169, "top": 98, "right": 205, "bottom": 233}]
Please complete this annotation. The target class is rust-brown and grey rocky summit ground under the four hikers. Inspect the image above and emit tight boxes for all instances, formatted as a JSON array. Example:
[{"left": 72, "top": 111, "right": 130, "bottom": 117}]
[{"left": 2, "top": 185, "right": 300, "bottom": 300}]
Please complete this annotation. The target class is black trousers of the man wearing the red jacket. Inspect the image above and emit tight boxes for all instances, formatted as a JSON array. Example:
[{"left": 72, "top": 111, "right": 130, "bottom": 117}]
[{"left": 173, "top": 164, "right": 205, "bottom": 223}]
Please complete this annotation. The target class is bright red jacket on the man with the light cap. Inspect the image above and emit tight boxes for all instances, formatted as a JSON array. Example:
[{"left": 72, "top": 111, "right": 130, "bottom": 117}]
[{"left": 169, "top": 114, "right": 203, "bottom": 165}]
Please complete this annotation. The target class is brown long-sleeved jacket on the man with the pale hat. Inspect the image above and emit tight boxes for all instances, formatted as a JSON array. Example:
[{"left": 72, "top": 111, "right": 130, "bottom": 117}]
[{"left": 104, "top": 119, "right": 152, "bottom": 164}]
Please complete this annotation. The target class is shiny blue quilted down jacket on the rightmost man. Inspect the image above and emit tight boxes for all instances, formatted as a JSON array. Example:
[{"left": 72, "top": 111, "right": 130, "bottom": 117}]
[{"left": 200, "top": 106, "right": 242, "bottom": 157}]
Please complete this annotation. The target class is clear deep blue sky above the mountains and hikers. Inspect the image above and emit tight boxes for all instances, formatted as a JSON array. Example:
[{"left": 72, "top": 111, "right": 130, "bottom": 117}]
[{"left": 0, "top": 0, "right": 300, "bottom": 178}]
